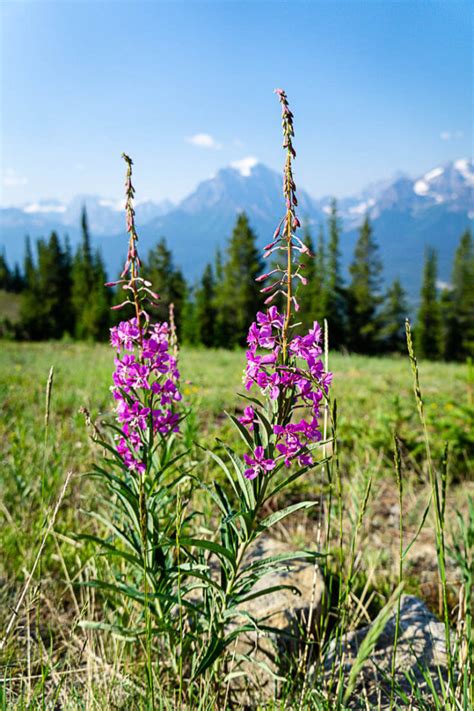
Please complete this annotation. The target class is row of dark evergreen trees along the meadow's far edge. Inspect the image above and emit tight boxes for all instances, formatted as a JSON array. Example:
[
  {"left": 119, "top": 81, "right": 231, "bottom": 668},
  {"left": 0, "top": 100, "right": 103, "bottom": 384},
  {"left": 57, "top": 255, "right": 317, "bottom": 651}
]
[{"left": 0, "top": 206, "right": 474, "bottom": 360}]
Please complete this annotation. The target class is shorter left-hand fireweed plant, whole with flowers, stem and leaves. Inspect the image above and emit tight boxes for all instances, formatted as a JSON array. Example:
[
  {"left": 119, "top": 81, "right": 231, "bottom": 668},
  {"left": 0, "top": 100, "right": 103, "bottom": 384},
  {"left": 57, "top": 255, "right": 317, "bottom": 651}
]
[{"left": 82, "top": 154, "right": 193, "bottom": 694}]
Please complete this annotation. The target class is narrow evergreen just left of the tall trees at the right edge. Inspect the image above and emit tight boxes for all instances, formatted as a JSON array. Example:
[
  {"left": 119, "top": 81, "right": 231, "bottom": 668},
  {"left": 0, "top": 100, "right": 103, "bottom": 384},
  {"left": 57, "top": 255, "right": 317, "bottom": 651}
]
[{"left": 415, "top": 248, "right": 441, "bottom": 359}]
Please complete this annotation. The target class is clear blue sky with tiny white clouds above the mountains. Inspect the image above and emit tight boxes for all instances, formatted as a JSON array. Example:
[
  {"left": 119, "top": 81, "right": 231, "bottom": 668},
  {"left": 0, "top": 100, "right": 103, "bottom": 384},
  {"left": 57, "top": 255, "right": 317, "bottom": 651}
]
[{"left": 0, "top": 0, "right": 472, "bottom": 205}]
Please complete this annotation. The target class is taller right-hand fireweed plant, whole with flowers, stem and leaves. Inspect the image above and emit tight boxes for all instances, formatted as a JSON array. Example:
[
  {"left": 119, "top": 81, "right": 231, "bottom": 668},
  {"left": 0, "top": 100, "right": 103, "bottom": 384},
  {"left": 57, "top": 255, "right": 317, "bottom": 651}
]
[{"left": 186, "top": 89, "right": 332, "bottom": 678}]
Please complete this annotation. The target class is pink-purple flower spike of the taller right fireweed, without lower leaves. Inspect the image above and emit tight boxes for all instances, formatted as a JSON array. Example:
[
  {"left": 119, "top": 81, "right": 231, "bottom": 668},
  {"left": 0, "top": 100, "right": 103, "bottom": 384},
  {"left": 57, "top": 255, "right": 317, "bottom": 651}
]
[{"left": 240, "top": 89, "right": 332, "bottom": 479}]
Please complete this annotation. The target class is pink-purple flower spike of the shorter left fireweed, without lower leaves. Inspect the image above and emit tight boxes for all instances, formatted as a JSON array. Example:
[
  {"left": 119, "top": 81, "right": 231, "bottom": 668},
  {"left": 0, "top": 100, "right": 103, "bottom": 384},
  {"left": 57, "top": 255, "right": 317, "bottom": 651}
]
[{"left": 108, "top": 153, "right": 181, "bottom": 474}]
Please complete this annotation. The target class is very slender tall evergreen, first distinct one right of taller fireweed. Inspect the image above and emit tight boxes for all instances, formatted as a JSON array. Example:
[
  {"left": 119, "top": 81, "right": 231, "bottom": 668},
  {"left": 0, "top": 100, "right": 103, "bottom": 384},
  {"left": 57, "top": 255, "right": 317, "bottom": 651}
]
[{"left": 324, "top": 200, "right": 347, "bottom": 348}]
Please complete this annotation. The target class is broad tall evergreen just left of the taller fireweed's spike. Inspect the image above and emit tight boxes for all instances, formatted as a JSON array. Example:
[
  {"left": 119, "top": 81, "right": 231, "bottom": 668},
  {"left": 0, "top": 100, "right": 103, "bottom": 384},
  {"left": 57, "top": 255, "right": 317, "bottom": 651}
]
[{"left": 216, "top": 213, "right": 263, "bottom": 348}]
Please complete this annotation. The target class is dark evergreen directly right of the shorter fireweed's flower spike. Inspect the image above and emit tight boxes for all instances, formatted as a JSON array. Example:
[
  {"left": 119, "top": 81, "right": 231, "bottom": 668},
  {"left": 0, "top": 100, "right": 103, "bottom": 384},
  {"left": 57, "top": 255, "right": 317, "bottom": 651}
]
[{"left": 142, "top": 238, "right": 187, "bottom": 338}]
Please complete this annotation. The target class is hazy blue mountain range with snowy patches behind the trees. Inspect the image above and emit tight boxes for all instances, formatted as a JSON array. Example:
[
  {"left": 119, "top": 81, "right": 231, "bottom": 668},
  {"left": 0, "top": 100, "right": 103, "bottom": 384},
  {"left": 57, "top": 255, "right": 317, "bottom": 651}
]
[{"left": 0, "top": 158, "right": 474, "bottom": 298}]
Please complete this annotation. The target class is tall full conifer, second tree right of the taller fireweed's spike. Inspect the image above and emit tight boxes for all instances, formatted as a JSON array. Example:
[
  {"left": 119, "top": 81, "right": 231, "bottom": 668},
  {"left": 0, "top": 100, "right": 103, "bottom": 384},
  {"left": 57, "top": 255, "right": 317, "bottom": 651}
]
[{"left": 348, "top": 216, "right": 382, "bottom": 354}]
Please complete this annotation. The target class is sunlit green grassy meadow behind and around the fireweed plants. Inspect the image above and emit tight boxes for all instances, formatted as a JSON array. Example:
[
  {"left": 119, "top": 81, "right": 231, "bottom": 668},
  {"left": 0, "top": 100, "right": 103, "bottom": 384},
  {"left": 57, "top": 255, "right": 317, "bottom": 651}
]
[{"left": 0, "top": 342, "right": 474, "bottom": 708}]
